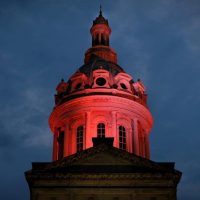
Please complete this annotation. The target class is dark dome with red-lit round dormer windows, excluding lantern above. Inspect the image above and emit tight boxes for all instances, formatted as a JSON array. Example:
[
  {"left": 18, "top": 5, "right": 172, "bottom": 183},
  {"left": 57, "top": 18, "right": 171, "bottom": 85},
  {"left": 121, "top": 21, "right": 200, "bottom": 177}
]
[{"left": 55, "top": 54, "right": 147, "bottom": 106}]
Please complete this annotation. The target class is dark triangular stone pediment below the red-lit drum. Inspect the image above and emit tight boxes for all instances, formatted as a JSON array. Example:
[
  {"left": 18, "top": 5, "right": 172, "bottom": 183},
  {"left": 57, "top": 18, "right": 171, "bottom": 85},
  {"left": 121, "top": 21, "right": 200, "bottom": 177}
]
[{"left": 46, "top": 144, "right": 178, "bottom": 172}]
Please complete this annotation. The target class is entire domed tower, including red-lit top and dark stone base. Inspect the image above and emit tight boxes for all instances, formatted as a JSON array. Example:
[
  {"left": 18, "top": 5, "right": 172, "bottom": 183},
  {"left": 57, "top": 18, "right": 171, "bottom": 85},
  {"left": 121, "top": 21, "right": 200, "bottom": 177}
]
[{"left": 25, "top": 9, "right": 181, "bottom": 200}]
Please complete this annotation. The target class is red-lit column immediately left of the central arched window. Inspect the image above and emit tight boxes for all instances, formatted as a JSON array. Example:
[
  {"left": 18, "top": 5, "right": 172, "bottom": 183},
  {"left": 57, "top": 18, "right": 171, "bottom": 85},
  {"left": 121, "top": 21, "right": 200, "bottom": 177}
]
[{"left": 83, "top": 111, "right": 92, "bottom": 149}]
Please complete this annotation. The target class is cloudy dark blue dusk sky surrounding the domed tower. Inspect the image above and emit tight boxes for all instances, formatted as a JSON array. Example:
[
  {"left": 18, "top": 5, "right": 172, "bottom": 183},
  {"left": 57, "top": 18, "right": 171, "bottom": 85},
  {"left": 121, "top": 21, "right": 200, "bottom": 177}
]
[{"left": 0, "top": 0, "right": 200, "bottom": 200}]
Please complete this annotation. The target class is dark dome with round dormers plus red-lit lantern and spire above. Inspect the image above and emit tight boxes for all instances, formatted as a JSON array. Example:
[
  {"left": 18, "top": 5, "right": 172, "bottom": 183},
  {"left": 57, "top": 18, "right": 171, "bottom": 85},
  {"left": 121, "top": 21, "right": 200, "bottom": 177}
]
[{"left": 52, "top": 8, "right": 147, "bottom": 106}]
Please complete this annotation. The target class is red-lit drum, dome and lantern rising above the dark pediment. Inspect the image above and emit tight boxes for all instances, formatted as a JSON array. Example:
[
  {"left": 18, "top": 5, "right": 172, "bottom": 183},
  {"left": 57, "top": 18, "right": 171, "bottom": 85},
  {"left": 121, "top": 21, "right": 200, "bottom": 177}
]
[{"left": 49, "top": 9, "right": 153, "bottom": 160}]
